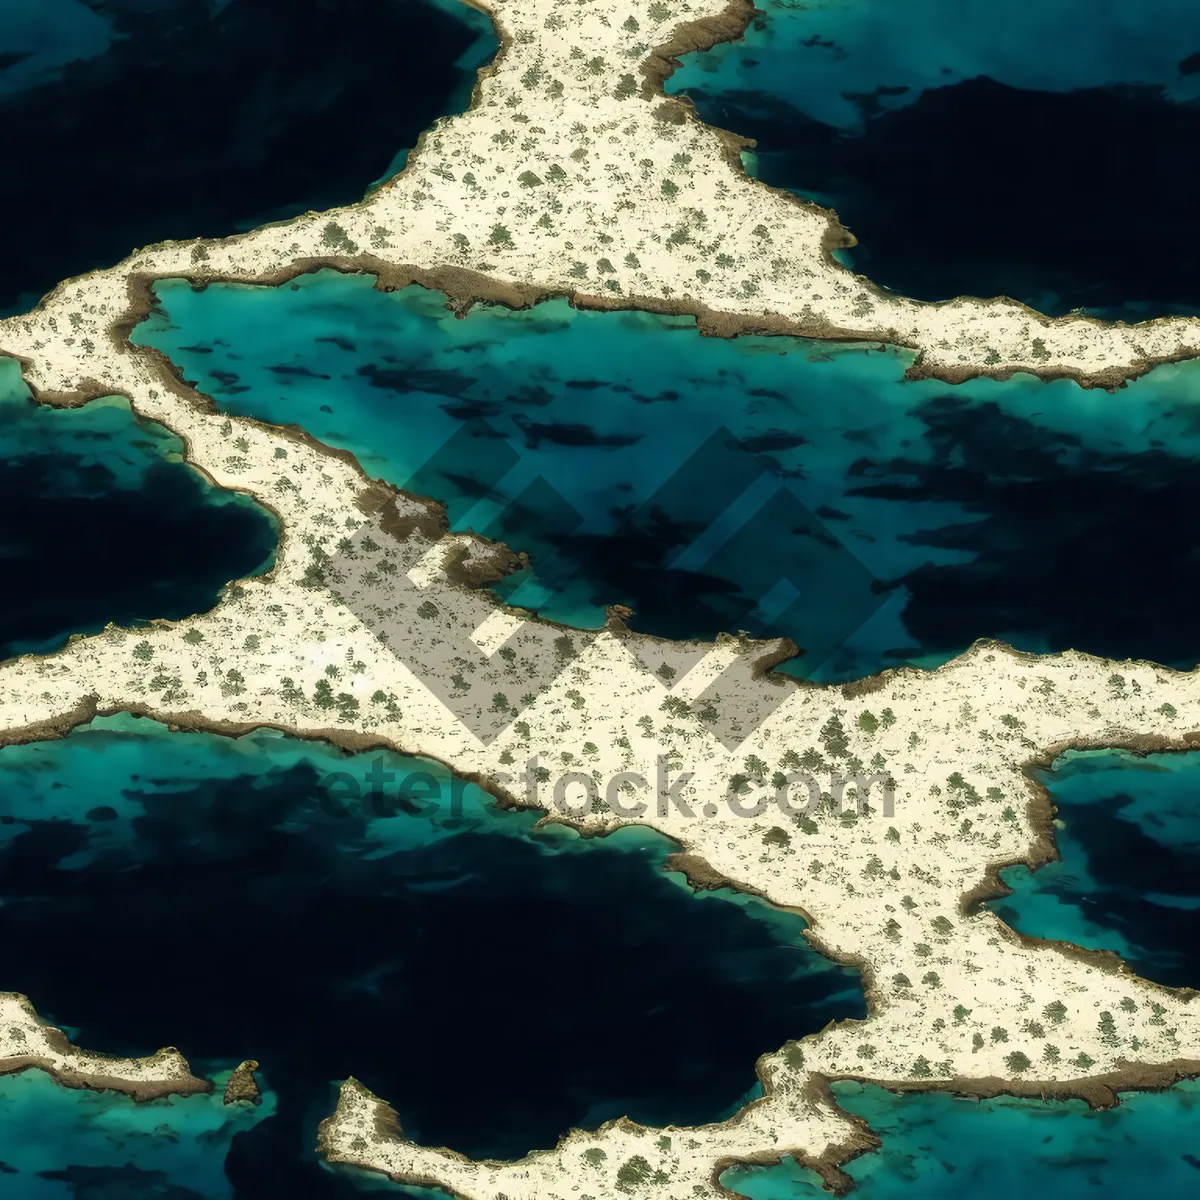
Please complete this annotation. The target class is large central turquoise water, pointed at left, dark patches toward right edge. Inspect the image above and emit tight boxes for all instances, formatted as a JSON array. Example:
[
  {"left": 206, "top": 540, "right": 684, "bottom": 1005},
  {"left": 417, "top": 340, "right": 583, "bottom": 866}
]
[{"left": 136, "top": 271, "right": 1200, "bottom": 679}]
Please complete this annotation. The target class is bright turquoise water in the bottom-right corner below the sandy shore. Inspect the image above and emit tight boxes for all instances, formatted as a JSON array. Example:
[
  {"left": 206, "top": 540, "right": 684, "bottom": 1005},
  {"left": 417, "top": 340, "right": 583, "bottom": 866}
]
[{"left": 721, "top": 1082, "right": 1200, "bottom": 1200}]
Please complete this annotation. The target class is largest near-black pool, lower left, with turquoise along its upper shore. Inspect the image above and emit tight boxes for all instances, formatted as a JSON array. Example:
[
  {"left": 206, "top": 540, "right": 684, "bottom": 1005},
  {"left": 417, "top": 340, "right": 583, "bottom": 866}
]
[{"left": 0, "top": 718, "right": 865, "bottom": 1200}]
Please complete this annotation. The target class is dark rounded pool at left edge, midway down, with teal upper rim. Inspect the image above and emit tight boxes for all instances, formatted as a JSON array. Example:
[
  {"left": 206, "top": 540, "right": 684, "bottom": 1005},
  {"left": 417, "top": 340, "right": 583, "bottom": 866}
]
[{"left": 0, "top": 358, "right": 277, "bottom": 659}]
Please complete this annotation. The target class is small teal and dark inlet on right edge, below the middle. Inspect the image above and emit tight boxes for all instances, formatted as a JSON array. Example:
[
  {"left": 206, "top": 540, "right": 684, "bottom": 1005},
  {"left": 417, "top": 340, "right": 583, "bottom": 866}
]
[{"left": 991, "top": 750, "right": 1200, "bottom": 988}]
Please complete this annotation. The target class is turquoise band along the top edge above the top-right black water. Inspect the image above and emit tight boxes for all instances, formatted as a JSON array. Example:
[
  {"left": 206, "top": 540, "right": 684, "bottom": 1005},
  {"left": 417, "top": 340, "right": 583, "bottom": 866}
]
[{"left": 666, "top": 0, "right": 1200, "bottom": 134}]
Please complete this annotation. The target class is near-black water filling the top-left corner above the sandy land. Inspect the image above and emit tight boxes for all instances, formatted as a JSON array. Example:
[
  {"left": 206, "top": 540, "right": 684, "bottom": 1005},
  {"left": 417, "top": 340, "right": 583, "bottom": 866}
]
[{"left": 0, "top": 0, "right": 499, "bottom": 313}]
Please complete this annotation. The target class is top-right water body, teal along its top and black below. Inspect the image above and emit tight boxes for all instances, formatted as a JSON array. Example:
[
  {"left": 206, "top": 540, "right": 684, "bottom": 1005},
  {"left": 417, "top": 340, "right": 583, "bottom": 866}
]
[{"left": 667, "top": 0, "right": 1200, "bottom": 319}]
